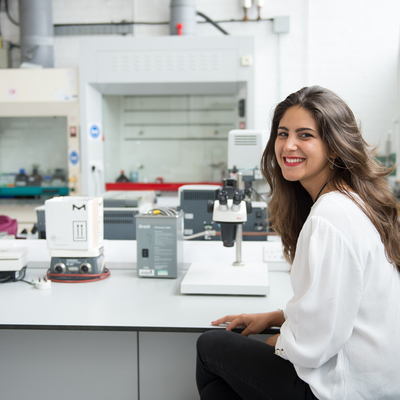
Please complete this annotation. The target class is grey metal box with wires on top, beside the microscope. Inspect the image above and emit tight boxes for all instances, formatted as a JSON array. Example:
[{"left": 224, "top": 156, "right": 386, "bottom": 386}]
[{"left": 136, "top": 208, "right": 183, "bottom": 278}]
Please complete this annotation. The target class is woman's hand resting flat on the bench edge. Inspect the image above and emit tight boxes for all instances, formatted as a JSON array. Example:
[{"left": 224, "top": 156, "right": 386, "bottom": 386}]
[{"left": 212, "top": 311, "right": 285, "bottom": 336}]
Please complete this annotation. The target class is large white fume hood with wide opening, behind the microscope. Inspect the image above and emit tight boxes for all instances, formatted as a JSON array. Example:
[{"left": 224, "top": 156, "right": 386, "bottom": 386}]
[{"left": 79, "top": 36, "right": 254, "bottom": 195}]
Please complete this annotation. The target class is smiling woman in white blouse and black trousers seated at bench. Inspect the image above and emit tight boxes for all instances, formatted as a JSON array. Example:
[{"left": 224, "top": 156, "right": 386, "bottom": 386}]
[{"left": 197, "top": 86, "right": 400, "bottom": 400}]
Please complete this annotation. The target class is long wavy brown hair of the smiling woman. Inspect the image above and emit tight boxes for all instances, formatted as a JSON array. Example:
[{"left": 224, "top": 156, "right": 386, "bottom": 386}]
[{"left": 261, "top": 86, "right": 400, "bottom": 272}]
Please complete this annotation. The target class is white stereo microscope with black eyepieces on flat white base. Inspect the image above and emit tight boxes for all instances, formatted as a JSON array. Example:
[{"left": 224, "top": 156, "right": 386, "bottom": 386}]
[{"left": 181, "top": 173, "right": 269, "bottom": 296}]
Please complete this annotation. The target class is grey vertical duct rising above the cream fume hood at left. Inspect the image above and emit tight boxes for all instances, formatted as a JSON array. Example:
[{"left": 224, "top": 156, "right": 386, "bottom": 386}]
[{"left": 19, "top": 0, "right": 54, "bottom": 68}]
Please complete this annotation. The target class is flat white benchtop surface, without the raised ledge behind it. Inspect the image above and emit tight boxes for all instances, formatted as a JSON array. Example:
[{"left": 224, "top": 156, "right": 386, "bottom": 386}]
[{"left": 0, "top": 264, "right": 292, "bottom": 331}]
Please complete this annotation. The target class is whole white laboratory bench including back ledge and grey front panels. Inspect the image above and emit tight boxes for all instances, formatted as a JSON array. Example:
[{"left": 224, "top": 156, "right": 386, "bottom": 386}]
[{"left": 0, "top": 240, "right": 292, "bottom": 400}]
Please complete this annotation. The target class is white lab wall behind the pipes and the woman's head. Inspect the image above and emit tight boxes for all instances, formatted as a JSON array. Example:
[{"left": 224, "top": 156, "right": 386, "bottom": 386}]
[{"left": 1, "top": 0, "right": 400, "bottom": 155}]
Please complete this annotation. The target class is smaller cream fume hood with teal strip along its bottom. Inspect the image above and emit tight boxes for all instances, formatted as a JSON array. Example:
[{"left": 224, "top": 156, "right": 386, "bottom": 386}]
[{"left": 0, "top": 68, "right": 81, "bottom": 197}]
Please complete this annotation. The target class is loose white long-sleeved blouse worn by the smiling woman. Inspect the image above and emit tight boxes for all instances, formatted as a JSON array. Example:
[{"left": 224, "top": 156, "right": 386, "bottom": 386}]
[{"left": 275, "top": 192, "right": 400, "bottom": 400}]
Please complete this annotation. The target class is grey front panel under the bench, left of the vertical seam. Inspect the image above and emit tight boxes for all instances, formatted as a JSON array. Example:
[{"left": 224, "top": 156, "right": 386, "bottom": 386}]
[{"left": 0, "top": 328, "right": 138, "bottom": 400}]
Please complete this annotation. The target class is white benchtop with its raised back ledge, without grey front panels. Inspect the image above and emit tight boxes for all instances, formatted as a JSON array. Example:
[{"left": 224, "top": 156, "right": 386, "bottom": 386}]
[{"left": 0, "top": 240, "right": 292, "bottom": 331}]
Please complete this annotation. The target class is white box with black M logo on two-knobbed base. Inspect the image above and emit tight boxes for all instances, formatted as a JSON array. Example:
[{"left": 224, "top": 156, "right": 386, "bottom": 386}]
[{"left": 45, "top": 197, "right": 110, "bottom": 282}]
